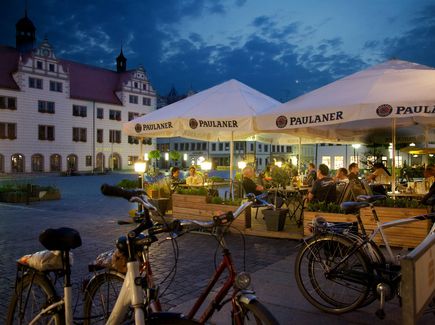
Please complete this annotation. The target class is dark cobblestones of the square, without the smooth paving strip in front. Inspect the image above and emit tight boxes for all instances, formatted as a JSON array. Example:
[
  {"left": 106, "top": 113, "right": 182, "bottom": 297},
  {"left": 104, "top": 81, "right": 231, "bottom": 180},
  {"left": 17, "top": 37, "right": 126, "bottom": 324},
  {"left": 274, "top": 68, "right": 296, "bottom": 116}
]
[{"left": 0, "top": 174, "right": 295, "bottom": 323}]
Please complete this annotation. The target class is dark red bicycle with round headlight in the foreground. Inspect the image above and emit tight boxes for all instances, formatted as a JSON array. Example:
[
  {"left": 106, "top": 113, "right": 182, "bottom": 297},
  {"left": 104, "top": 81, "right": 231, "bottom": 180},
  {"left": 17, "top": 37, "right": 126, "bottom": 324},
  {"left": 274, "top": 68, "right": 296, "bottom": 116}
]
[{"left": 84, "top": 185, "right": 278, "bottom": 324}]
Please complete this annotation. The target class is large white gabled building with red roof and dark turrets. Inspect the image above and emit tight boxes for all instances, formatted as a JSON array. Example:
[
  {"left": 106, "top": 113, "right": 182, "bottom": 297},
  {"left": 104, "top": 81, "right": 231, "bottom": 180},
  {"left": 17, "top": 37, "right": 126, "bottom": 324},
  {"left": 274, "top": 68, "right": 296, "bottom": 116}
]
[{"left": 0, "top": 12, "right": 156, "bottom": 173}]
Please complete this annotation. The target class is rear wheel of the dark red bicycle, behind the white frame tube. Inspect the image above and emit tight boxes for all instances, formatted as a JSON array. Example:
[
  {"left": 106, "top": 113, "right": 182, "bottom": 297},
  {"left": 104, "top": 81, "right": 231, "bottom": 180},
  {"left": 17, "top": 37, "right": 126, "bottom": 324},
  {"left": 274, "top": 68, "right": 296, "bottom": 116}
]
[{"left": 83, "top": 271, "right": 129, "bottom": 325}]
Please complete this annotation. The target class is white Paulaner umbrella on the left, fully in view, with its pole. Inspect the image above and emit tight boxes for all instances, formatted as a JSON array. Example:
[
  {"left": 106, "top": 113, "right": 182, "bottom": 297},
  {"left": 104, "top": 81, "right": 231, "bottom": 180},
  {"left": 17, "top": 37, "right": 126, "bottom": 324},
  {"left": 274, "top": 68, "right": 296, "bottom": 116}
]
[{"left": 123, "top": 79, "right": 296, "bottom": 192}]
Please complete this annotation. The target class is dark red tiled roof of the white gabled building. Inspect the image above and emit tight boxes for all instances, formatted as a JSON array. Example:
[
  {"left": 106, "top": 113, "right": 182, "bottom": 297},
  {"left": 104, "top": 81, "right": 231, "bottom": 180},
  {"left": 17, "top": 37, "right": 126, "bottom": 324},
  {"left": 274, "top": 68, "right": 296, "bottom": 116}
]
[{"left": 0, "top": 45, "right": 146, "bottom": 105}]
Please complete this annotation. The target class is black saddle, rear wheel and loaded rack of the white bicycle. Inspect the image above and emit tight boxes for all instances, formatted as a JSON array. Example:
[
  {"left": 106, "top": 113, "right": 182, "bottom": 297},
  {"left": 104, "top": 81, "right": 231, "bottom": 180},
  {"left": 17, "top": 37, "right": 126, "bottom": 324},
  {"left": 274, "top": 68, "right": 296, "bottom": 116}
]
[{"left": 6, "top": 227, "right": 81, "bottom": 325}]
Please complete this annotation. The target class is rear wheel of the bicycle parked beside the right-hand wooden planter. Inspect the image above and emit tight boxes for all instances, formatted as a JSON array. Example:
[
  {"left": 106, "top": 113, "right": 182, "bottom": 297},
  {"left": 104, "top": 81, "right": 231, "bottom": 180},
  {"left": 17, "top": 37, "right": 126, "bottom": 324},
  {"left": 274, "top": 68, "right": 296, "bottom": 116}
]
[{"left": 295, "top": 235, "right": 371, "bottom": 314}]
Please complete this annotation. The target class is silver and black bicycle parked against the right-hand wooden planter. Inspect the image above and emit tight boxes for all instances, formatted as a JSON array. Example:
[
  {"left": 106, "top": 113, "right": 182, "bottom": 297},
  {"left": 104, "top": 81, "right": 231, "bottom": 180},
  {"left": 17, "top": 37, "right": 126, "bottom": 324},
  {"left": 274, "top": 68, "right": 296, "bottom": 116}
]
[{"left": 295, "top": 195, "right": 435, "bottom": 319}]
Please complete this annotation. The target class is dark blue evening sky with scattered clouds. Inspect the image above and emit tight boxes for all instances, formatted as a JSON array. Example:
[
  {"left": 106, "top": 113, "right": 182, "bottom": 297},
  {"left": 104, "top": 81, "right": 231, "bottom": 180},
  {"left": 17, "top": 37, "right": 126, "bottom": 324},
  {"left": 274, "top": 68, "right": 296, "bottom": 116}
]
[{"left": 0, "top": 0, "right": 435, "bottom": 102}]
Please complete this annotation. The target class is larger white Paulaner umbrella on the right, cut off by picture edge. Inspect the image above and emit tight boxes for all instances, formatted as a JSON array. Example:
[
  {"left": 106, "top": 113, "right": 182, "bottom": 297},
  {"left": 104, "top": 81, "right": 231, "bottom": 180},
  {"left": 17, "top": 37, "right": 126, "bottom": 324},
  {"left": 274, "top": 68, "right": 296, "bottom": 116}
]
[{"left": 256, "top": 60, "right": 435, "bottom": 190}]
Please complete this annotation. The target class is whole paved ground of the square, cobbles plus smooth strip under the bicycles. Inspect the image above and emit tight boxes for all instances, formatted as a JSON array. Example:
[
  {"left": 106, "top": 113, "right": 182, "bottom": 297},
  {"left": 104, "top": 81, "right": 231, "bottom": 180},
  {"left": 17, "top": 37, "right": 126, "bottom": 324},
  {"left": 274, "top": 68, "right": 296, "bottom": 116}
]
[{"left": 0, "top": 174, "right": 434, "bottom": 325}]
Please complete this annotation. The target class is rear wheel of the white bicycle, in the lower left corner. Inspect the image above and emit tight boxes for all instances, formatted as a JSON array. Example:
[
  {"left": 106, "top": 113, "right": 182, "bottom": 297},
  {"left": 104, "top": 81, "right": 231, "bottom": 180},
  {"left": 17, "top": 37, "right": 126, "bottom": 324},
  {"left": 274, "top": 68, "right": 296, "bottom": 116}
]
[{"left": 6, "top": 273, "right": 64, "bottom": 325}]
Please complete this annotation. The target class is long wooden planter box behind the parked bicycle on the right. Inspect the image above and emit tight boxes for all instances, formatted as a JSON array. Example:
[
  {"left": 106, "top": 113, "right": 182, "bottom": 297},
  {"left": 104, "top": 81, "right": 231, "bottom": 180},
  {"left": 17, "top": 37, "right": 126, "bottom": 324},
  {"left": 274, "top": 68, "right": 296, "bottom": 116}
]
[{"left": 304, "top": 207, "right": 431, "bottom": 247}]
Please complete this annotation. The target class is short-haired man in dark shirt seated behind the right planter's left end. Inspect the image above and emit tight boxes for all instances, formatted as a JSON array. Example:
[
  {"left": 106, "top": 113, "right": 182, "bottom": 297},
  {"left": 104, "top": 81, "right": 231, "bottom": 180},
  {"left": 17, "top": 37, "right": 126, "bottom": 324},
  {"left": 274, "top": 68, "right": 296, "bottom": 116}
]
[{"left": 307, "top": 164, "right": 337, "bottom": 202}]
